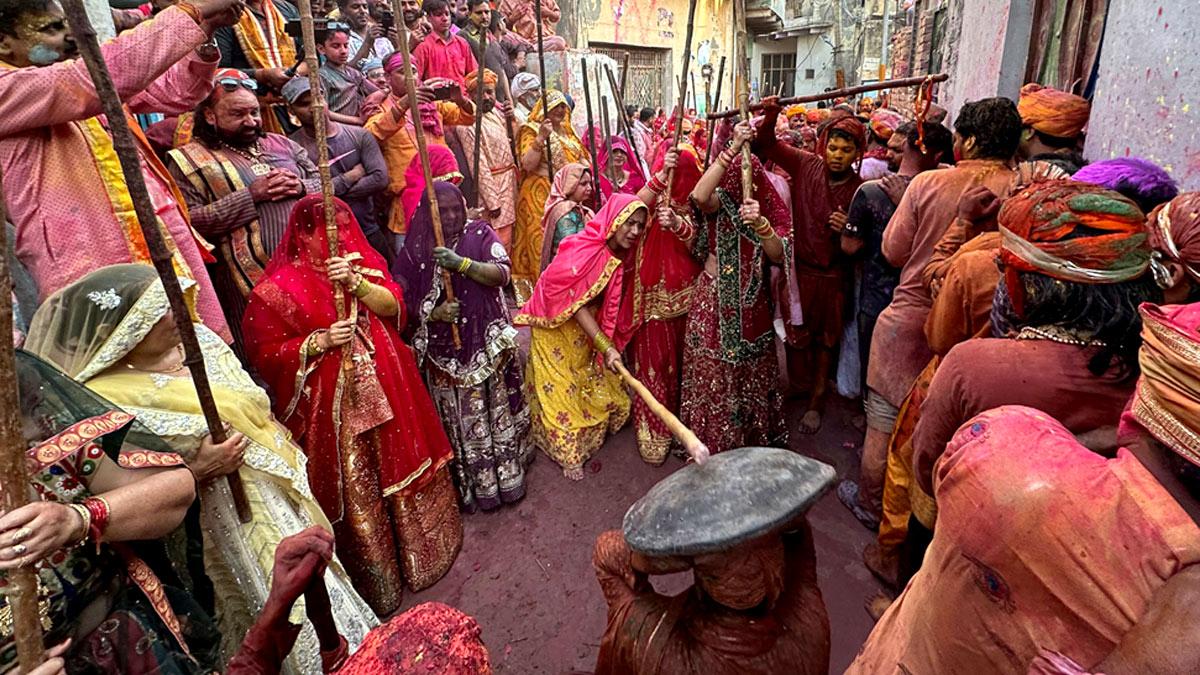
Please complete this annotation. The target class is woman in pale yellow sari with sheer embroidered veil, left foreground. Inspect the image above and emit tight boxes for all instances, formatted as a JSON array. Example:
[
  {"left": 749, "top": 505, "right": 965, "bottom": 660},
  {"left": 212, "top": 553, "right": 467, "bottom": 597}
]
[{"left": 25, "top": 264, "right": 378, "bottom": 675}]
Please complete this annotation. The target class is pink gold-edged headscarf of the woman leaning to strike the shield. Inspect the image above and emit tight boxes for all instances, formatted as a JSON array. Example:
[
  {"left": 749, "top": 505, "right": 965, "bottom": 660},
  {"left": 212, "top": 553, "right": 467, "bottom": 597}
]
[{"left": 512, "top": 193, "right": 646, "bottom": 350}]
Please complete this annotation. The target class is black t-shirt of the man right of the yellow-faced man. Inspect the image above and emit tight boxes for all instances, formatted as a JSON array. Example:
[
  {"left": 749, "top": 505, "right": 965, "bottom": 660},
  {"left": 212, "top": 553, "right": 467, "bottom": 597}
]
[{"left": 842, "top": 179, "right": 910, "bottom": 316}]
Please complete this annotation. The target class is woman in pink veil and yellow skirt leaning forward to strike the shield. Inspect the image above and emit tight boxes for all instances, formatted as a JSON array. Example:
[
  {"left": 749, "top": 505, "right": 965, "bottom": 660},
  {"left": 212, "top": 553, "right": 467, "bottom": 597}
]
[{"left": 512, "top": 195, "right": 649, "bottom": 480}]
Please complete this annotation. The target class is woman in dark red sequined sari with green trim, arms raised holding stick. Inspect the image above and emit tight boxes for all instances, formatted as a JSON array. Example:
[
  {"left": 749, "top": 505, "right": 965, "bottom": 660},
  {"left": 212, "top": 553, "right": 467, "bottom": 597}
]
[{"left": 679, "top": 123, "right": 792, "bottom": 453}]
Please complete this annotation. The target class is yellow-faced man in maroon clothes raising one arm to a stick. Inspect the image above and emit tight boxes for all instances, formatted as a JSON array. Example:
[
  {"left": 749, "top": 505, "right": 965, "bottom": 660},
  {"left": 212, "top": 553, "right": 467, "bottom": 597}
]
[{"left": 754, "top": 96, "right": 866, "bottom": 434}]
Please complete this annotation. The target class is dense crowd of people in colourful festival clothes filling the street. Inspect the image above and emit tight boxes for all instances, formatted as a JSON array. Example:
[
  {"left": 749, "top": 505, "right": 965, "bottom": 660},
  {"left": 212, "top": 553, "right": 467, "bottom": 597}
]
[{"left": 0, "top": 0, "right": 1200, "bottom": 674}]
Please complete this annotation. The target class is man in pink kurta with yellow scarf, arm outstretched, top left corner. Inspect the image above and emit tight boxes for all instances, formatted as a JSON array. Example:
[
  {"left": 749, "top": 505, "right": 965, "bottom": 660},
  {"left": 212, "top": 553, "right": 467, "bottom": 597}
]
[{"left": 0, "top": 0, "right": 240, "bottom": 339}]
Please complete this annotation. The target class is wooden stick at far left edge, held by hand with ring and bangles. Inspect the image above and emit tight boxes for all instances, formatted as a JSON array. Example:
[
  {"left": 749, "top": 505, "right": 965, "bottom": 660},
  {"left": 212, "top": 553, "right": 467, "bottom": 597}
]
[{"left": 0, "top": 171, "right": 44, "bottom": 673}]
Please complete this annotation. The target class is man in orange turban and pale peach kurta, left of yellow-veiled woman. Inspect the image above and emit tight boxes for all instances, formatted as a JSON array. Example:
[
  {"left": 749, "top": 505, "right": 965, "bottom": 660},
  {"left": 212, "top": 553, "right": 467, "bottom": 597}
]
[{"left": 452, "top": 70, "right": 517, "bottom": 243}]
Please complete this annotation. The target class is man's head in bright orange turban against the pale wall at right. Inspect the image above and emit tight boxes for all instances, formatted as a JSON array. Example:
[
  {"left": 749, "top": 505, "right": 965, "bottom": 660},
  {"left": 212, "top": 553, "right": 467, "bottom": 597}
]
[{"left": 1016, "top": 83, "right": 1092, "bottom": 173}]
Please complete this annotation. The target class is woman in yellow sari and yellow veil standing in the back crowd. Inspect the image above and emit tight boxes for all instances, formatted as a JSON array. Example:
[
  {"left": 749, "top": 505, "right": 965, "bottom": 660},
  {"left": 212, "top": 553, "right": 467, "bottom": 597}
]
[{"left": 512, "top": 89, "right": 588, "bottom": 305}]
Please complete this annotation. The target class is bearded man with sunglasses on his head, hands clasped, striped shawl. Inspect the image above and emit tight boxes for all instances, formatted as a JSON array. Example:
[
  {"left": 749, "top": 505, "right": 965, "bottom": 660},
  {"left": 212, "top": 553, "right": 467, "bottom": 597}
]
[{"left": 168, "top": 68, "right": 320, "bottom": 348}]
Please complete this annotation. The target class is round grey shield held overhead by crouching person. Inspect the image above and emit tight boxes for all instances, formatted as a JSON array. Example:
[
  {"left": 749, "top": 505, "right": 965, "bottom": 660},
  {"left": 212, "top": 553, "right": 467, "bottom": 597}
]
[{"left": 624, "top": 448, "right": 836, "bottom": 556}]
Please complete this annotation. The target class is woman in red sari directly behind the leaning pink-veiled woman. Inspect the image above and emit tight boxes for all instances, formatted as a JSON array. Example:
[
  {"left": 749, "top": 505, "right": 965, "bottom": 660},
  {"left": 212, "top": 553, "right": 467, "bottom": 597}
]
[{"left": 622, "top": 139, "right": 703, "bottom": 465}]
